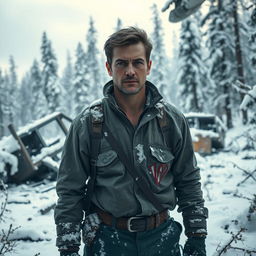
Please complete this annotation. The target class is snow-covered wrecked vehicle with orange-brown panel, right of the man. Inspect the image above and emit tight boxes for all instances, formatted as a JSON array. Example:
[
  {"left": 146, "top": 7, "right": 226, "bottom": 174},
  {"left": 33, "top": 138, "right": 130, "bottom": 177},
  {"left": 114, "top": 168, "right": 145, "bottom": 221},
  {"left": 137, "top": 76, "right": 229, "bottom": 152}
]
[{"left": 185, "top": 113, "right": 227, "bottom": 154}]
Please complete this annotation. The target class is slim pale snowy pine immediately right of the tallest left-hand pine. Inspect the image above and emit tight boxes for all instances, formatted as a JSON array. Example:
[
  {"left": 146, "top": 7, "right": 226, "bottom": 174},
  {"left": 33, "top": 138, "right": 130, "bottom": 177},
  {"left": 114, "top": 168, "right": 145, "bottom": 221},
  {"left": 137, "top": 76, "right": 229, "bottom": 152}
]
[{"left": 61, "top": 51, "right": 74, "bottom": 116}]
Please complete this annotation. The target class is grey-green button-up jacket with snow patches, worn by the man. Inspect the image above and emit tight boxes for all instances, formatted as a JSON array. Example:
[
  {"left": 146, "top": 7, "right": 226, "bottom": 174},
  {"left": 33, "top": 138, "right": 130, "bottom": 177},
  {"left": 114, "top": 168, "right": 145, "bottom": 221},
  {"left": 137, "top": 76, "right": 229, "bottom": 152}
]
[{"left": 55, "top": 81, "right": 207, "bottom": 252}]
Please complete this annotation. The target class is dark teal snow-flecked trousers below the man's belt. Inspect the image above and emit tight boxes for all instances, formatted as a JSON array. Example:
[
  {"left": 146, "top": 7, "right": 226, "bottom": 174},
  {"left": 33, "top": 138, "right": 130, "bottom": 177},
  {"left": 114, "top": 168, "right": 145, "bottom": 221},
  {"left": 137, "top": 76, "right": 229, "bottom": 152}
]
[{"left": 84, "top": 218, "right": 182, "bottom": 256}]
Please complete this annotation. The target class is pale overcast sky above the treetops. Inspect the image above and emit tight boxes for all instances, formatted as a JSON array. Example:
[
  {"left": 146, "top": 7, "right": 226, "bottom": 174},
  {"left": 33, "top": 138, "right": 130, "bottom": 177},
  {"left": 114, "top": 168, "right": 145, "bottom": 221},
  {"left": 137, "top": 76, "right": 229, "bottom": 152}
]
[{"left": 0, "top": 0, "right": 182, "bottom": 79}]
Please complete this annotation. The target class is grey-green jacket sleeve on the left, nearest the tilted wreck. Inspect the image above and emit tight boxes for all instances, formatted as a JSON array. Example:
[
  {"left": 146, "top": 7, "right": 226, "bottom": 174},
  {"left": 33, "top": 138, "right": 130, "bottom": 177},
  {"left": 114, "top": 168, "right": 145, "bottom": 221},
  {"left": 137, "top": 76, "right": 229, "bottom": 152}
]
[{"left": 54, "top": 114, "right": 90, "bottom": 250}]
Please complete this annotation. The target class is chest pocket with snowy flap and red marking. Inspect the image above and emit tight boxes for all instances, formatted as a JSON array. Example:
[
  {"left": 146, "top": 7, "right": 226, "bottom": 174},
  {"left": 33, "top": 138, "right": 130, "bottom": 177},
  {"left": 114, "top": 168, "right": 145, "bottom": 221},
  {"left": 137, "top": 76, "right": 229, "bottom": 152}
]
[{"left": 147, "top": 145, "right": 174, "bottom": 185}]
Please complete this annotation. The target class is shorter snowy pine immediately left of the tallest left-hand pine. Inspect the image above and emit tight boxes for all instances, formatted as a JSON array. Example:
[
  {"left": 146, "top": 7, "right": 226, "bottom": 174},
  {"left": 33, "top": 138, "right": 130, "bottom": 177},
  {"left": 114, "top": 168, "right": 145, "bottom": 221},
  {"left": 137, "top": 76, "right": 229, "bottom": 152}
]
[{"left": 30, "top": 60, "right": 48, "bottom": 120}]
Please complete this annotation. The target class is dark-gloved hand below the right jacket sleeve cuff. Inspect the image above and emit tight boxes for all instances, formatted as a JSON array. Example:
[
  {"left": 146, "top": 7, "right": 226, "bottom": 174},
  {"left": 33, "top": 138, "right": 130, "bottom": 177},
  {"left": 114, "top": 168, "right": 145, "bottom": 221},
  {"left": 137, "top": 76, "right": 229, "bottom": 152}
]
[{"left": 183, "top": 237, "right": 206, "bottom": 256}]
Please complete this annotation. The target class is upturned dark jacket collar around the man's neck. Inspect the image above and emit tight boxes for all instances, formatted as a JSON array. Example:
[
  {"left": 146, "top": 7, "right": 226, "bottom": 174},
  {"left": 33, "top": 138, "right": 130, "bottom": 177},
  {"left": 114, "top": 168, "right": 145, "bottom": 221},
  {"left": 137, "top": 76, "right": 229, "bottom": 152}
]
[{"left": 103, "top": 80, "right": 163, "bottom": 107}]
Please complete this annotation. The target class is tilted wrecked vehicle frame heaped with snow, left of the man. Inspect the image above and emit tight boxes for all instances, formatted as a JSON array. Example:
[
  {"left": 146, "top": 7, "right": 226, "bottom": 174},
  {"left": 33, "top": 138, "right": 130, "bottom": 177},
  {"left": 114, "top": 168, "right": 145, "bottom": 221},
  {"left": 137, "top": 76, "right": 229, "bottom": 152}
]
[{"left": 0, "top": 112, "right": 72, "bottom": 184}]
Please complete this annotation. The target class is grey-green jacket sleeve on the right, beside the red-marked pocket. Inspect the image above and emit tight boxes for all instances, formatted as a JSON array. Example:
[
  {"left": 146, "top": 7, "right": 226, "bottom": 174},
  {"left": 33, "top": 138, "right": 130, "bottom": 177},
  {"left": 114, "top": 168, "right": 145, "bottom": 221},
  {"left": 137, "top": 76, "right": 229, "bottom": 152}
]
[{"left": 170, "top": 115, "right": 208, "bottom": 236}]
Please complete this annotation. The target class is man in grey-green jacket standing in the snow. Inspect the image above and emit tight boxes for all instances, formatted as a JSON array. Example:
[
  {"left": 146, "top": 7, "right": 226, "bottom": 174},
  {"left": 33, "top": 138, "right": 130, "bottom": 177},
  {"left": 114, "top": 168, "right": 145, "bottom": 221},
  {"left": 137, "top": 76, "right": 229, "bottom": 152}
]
[{"left": 55, "top": 27, "right": 207, "bottom": 256}]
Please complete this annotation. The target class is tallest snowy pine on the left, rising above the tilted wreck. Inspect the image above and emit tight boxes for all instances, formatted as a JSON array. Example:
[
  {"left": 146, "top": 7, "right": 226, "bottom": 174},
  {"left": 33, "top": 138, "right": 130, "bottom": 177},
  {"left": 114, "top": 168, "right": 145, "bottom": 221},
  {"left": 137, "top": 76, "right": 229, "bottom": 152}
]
[{"left": 41, "top": 32, "right": 62, "bottom": 113}]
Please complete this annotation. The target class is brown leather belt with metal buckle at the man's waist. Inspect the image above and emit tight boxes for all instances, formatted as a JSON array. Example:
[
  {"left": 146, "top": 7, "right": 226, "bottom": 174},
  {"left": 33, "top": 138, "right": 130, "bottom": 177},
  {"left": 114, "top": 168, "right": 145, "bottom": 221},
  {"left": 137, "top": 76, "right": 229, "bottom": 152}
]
[{"left": 95, "top": 208, "right": 169, "bottom": 232}]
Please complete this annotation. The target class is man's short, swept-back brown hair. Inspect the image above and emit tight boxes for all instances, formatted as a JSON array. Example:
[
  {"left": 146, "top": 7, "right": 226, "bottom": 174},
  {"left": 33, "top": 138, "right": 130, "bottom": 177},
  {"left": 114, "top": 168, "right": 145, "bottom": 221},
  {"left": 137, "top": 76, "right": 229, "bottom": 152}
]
[{"left": 104, "top": 27, "right": 153, "bottom": 65}]
